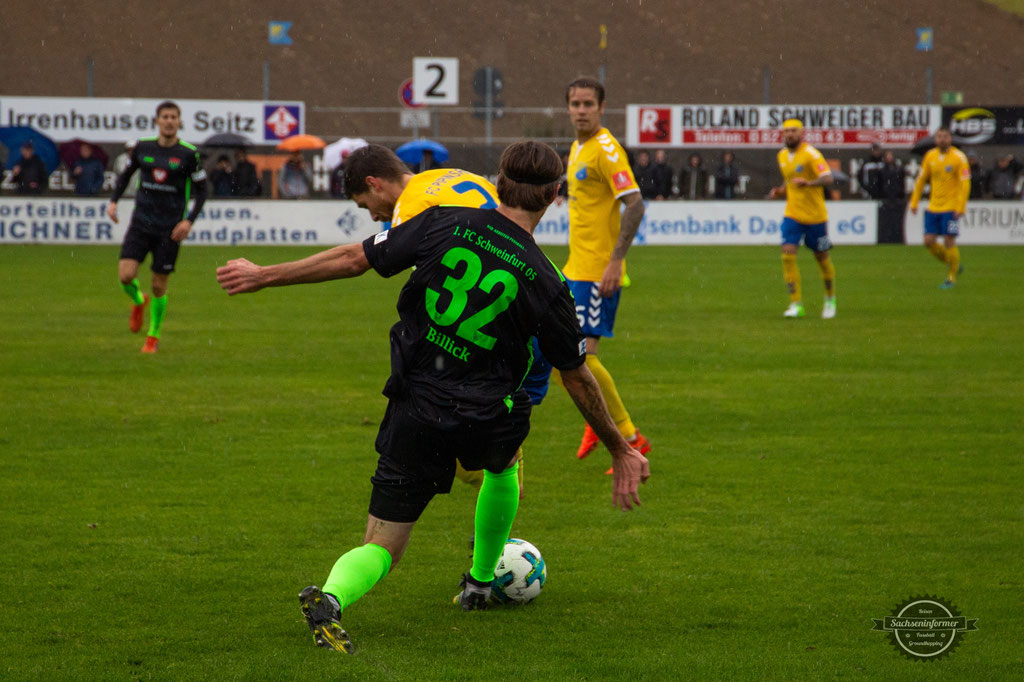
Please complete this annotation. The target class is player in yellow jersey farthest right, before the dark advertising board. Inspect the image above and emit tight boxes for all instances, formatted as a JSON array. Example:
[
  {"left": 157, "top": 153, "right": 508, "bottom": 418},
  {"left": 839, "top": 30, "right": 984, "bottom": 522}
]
[{"left": 910, "top": 128, "right": 971, "bottom": 289}]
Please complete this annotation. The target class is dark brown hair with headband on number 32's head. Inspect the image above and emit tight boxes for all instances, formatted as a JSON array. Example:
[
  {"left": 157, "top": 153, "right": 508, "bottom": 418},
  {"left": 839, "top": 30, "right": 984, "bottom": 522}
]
[{"left": 498, "top": 140, "right": 565, "bottom": 211}]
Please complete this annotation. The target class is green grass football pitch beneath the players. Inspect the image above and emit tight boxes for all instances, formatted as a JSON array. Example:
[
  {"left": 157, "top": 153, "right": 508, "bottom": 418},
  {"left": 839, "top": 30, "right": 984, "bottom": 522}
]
[{"left": 0, "top": 241, "right": 1024, "bottom": 680}]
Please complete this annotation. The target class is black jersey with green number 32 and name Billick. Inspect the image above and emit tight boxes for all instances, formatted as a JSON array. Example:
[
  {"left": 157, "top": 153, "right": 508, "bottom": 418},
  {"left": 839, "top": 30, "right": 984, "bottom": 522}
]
[{"left": 362, "top": 207, "right": 586, "bottom": 428}]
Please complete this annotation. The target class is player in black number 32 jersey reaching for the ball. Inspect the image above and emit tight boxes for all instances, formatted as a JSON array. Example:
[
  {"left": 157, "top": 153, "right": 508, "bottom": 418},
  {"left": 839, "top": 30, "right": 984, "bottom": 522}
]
[{"left": 217, "top": 141, "right": 649, "bottom": 652}]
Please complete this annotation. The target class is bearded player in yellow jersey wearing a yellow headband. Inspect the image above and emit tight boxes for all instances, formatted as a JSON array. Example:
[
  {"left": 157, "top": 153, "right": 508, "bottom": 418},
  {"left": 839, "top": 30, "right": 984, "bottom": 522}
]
[{"left": 769, "top": 119, "right": 836, "bottom": 319}]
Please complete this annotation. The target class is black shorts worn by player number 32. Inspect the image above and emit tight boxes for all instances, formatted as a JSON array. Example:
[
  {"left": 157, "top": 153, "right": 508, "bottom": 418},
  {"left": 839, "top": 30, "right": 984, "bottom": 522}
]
[{"left": 370, "top": 391, "right": 531, "bottom": 523}]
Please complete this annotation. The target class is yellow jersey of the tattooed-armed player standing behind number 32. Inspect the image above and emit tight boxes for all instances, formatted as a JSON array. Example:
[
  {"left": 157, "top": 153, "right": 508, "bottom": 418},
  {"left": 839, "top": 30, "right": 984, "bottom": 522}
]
[{"left": 562, "top": 128, "right": 640, "bottom": 282}]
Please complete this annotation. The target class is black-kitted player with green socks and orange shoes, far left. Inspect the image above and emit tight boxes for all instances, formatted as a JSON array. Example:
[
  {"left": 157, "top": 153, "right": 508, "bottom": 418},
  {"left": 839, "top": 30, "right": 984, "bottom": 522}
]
[{"left": 106, "top": 101, "right": 206, "bottom": 353}]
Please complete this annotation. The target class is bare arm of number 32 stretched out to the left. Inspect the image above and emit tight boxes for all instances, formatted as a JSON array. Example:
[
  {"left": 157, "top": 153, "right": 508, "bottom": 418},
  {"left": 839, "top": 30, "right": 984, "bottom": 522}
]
[{"left": 217, "top": 243, "right": 370, "bottom": 296}]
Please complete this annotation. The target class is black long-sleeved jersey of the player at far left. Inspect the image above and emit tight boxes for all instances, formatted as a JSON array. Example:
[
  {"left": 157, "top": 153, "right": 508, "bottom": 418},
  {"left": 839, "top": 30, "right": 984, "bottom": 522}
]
[{"left": 111, "top": 137, "right": 206, "bottom": 231}]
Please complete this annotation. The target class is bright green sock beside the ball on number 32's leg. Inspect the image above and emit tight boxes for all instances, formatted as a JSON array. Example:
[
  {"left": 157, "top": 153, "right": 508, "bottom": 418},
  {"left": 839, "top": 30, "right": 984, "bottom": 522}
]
[{"left": 469, "top": 462, "right": 519, "bottom": 583}]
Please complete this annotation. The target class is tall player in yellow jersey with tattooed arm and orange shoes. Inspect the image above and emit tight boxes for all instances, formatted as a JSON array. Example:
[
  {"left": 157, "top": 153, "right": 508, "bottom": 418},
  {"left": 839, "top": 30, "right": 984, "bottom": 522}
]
[{"left": 562, "top": 78, "right": 650, "bottom": 466}]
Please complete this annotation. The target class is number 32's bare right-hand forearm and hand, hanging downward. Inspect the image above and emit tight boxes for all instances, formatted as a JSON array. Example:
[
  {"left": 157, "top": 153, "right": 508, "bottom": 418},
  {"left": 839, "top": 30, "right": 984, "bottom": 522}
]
[{"left": 560, "top": 358, "right": 650, "bottom": 511}]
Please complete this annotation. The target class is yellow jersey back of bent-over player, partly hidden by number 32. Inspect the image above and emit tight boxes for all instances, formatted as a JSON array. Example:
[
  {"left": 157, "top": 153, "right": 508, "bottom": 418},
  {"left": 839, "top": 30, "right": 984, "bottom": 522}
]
[{"left": 391, "top": 168, "right": 498, "bottom": 227}]
